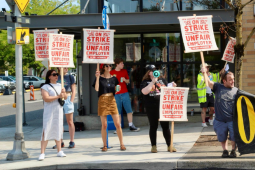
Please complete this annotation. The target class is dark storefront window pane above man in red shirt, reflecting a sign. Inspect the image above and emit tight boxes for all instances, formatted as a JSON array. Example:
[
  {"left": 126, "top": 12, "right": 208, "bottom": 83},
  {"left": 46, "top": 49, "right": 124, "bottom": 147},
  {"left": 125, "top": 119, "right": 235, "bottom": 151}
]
[{"left": 114, "top": 34, "right": 141, "bottom": 63}]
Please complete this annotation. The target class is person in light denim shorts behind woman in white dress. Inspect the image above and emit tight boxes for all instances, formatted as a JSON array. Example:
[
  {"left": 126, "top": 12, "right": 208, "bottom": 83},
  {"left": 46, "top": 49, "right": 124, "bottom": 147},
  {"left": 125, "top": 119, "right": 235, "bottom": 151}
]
[{"left": 53, "top": 67, "right": 76, "bottom": 149}]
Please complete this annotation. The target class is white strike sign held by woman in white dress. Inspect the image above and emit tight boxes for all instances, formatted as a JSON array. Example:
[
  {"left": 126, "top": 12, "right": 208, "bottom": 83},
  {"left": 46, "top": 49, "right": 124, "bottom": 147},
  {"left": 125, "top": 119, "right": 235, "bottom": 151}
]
[{"left": 49, "top": 34, "right": 74, "bottom": 68}]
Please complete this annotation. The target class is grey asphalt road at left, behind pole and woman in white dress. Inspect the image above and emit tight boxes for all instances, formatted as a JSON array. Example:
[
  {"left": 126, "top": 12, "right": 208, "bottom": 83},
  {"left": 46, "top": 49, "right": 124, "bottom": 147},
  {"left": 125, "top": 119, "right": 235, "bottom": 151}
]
[{"left": 0, "top": 91, "right": 77, "bottom": 127}]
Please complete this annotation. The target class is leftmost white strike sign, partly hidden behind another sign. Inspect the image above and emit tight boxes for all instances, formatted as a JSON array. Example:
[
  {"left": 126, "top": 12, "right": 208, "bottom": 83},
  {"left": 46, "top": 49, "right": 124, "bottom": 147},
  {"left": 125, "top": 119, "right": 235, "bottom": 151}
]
[{"left": 34, "top": 29, "right": 58, "bottom": 61}]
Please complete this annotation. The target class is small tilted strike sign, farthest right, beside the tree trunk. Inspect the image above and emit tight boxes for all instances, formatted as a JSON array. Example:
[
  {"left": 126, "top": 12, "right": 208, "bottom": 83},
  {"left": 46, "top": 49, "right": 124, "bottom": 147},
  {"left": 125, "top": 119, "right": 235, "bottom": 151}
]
[{"left": 221, "top": 38, "right": 236, "bottom": 63}]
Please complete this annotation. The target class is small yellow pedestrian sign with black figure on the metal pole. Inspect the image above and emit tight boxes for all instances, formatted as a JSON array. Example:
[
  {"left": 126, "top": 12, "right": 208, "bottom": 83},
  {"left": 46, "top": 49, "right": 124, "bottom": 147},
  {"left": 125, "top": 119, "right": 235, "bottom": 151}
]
[{"left": 16, "top": 27, "right": 29, "bottom": 45}]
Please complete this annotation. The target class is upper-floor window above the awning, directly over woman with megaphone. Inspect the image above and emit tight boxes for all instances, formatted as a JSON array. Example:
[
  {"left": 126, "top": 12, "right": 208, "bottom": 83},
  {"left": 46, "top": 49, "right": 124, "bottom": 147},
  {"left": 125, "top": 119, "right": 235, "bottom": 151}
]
[{"left": 143, "top": 0, "right": 180, "bottom": 12}]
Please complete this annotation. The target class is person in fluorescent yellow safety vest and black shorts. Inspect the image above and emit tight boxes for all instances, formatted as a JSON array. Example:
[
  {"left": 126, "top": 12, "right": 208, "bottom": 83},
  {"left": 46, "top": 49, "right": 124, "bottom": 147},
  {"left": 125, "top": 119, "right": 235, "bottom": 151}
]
[{"left": 197, "top": 63, "right": 224, "bottom": 127}]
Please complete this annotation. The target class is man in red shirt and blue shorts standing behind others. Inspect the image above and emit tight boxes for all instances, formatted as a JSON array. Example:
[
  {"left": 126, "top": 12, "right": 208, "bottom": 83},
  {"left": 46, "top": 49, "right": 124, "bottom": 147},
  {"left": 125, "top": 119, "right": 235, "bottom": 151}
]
[{"left": 110, "top": 58, "right": 140, "bottom": 133}]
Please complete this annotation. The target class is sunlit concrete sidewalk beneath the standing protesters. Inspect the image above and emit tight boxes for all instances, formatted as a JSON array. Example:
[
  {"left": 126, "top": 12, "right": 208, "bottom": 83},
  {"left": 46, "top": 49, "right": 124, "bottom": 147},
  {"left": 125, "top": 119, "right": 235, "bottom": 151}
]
[{"left": 0, "top": 122, "right": 202, "bottom": 169}]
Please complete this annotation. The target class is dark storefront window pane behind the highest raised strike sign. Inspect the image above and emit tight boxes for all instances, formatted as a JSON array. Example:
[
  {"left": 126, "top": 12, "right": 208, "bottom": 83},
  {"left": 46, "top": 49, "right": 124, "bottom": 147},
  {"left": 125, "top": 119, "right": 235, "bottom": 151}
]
[{"left": 183, "top": 33, "right": 221, "bottom": 62}]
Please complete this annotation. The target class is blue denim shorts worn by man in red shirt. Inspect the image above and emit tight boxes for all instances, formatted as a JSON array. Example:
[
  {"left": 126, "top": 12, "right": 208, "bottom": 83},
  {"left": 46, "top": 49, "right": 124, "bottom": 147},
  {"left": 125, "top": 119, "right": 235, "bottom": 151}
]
[{"left": 115, "top": 92, "right": 133, "bottom": 114}]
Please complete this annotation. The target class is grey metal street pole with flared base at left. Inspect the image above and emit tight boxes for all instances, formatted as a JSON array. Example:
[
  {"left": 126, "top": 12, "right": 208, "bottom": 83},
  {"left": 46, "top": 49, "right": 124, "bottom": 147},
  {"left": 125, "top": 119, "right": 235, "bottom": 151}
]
[{"left": 6, "top": 4, "right": 29, "bottom": 161}]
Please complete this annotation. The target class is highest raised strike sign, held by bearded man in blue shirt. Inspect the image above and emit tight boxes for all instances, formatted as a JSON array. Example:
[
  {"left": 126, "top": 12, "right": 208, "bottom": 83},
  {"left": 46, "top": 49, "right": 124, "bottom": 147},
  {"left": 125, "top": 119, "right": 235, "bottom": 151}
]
[{"left": 178, "top": 15, "right": 218, "bottom": 53}]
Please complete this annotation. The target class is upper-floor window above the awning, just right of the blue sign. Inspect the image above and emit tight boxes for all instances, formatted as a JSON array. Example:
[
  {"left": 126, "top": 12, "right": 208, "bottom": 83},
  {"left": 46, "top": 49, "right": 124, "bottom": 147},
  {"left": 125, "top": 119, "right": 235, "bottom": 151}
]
[{"left": 104, "top": 0, "right": 140, "bottom": 13}]
